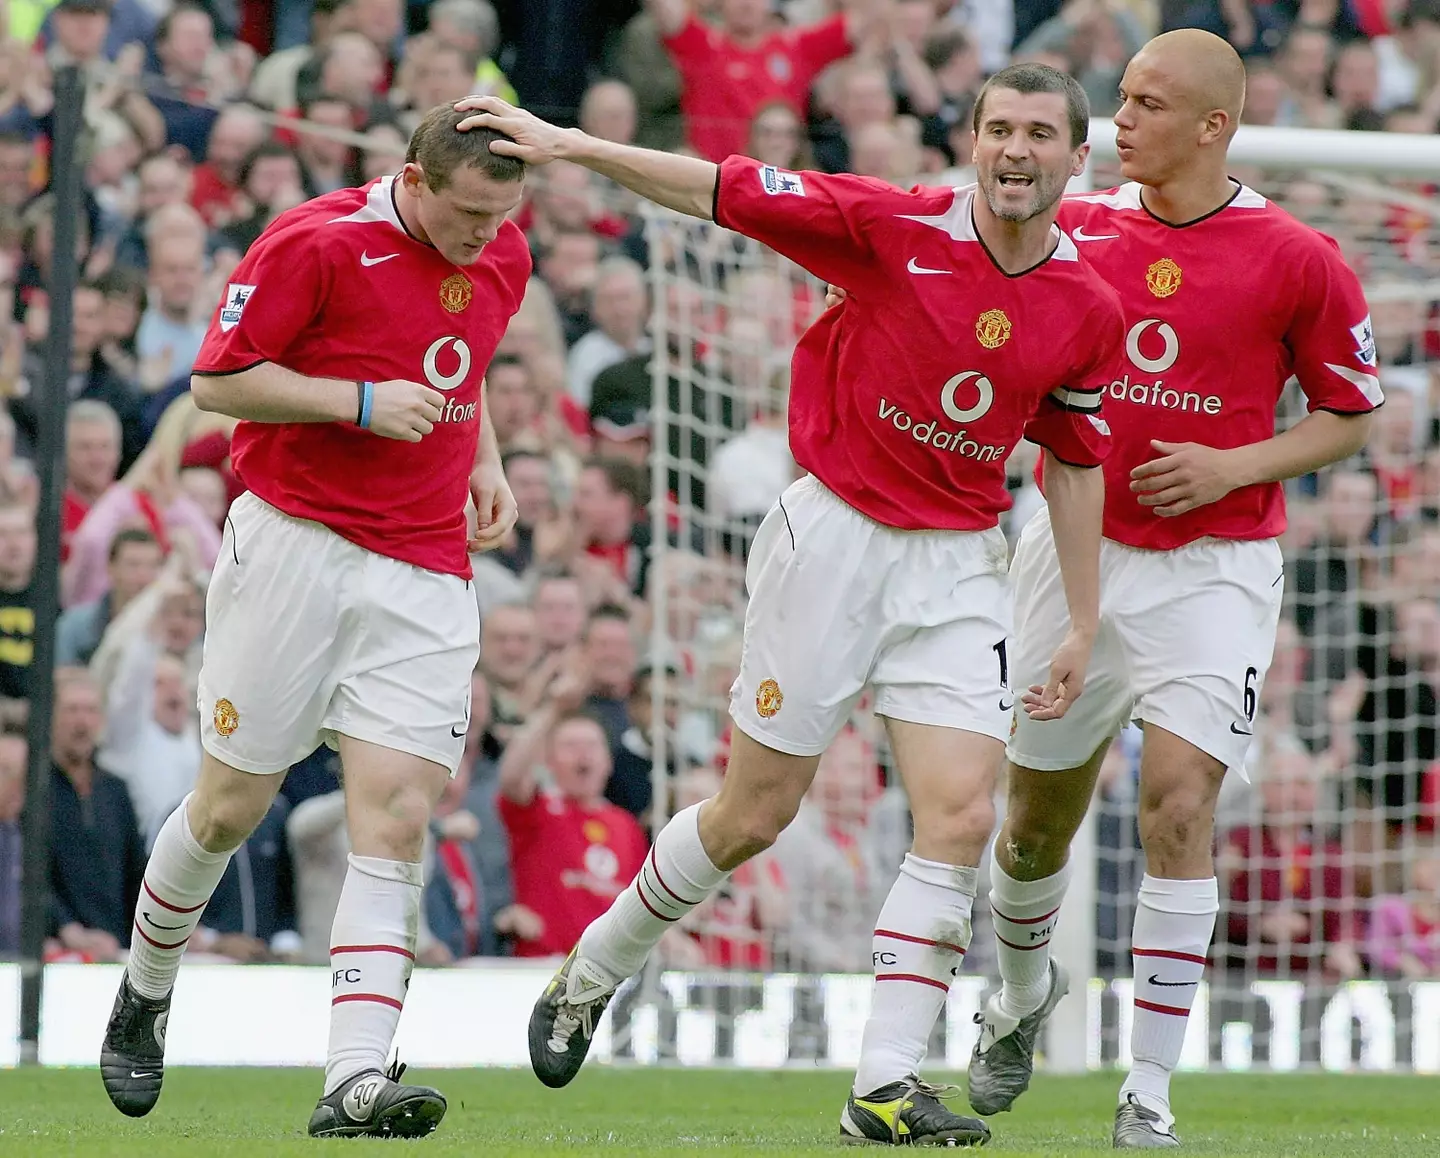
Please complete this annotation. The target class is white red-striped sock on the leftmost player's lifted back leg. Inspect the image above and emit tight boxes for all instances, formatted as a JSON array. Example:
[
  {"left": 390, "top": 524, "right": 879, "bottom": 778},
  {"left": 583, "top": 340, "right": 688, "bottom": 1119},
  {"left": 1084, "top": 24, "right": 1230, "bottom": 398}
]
[{"left": 125, "top": 796, "right": 235, "bottom": 1001}]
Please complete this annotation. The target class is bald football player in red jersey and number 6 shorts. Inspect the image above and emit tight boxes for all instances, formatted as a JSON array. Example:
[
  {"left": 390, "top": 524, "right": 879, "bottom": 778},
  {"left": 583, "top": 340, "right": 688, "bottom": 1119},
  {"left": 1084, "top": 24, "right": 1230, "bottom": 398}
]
[{"left": 969, "top": 29, "right": 1382, "bottom": 1149}]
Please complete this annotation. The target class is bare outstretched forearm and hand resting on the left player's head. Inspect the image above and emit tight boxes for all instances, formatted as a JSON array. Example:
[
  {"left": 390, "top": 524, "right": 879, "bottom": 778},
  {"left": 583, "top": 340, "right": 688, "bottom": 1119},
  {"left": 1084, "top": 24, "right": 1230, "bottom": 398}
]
[{"left": 455, "top": 97, "right": 720, "bottom": 220}]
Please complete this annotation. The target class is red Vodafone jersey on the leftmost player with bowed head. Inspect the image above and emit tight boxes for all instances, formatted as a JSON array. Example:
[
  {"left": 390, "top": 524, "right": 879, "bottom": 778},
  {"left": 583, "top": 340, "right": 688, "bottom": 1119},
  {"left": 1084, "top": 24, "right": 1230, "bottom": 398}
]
[{"left": 194, "top": 177, "right": 530, "bottom": 579}]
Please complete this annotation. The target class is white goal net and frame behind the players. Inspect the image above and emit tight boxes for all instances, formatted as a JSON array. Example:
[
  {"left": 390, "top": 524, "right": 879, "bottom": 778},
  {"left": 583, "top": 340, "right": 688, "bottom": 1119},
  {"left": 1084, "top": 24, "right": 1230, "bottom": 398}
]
[{"left": 627, "top": 121, "right": 1440, "bottom": 1072}]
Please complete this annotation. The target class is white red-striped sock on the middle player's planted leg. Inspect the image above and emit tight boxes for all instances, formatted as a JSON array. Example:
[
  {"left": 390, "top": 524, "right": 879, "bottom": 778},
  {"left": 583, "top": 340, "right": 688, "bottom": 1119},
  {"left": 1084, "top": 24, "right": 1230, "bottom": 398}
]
[{"left": 854, "top": 853, "right": 978, "bottom": 1098}]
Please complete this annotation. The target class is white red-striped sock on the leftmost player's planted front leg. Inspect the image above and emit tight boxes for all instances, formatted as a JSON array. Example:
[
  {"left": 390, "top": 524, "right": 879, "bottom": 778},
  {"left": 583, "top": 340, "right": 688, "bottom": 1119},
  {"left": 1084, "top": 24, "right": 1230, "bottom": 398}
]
[{"left": 325, "top": 853, "right": 425, "bottom": 1096}]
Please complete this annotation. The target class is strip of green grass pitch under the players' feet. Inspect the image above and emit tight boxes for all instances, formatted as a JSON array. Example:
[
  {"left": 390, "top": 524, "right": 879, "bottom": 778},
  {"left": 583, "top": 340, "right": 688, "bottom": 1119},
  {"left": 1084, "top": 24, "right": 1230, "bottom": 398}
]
[{"left": 0, "top": 1069, "right": 1440, "bottom": 1158}]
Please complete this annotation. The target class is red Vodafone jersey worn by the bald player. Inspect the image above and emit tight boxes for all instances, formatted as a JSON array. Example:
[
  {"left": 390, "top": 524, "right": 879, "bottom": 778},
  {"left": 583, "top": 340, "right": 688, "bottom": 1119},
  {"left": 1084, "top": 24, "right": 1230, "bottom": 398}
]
[{"left": 1060, "top": 183, "right": 1382, "bottom": 550}]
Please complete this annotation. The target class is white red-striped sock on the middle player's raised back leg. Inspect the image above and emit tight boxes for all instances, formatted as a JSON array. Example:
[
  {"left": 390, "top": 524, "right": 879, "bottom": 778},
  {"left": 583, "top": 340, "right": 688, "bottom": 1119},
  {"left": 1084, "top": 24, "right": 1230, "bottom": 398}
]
[{"left": 580, "top": 804, "right": 730, "bottom": 981}]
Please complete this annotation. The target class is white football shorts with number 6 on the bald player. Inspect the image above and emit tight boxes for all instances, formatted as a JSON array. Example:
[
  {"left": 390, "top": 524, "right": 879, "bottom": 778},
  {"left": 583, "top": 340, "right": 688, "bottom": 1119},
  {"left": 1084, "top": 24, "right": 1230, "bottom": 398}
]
[{"left": 1005, "top": 508, "right": 1284, "bottom": 772}]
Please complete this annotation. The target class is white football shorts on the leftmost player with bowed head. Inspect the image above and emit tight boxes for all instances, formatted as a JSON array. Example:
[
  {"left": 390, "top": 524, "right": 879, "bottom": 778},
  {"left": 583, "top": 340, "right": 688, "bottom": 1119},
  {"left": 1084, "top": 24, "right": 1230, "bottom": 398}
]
[{"left": 199, "top": 494, "right": 480, "bottom": 775}]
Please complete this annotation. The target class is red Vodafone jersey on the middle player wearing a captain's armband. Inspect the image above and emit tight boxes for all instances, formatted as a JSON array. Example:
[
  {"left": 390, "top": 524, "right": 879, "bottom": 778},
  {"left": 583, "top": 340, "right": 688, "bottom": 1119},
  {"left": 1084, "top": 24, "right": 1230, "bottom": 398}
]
[{"left": 716, "top": 157, "right": 1123, "bottom": 530}]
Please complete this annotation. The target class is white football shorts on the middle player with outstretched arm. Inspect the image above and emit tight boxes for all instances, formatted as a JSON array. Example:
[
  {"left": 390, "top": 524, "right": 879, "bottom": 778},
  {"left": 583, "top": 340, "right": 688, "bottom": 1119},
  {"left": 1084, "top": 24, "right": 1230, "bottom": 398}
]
[{"left": 730, "top": 475, "right": 1014, "bottom": 756}]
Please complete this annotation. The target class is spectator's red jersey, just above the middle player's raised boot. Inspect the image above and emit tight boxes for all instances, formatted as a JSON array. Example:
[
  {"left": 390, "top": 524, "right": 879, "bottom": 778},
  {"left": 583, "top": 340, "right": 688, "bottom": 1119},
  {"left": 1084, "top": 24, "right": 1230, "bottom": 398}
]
[{"left": 500, "top": 792, "right": 647, "bottom": 956}]
